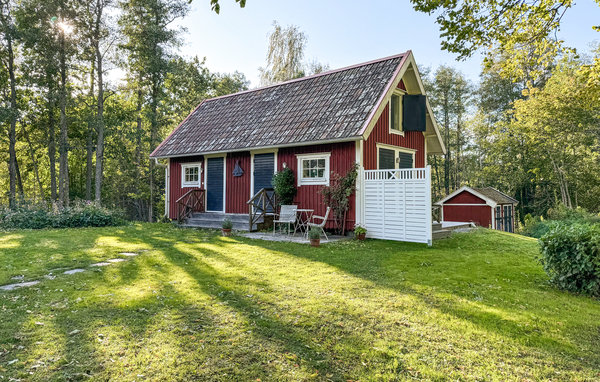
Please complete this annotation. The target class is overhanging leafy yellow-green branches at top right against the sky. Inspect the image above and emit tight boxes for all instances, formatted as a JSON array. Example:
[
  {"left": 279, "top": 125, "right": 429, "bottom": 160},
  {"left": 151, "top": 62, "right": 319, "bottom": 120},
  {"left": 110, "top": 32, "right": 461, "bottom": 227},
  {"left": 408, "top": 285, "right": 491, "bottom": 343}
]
[{"left": 411, "top": 0, "right": 573, "bottom": 83}]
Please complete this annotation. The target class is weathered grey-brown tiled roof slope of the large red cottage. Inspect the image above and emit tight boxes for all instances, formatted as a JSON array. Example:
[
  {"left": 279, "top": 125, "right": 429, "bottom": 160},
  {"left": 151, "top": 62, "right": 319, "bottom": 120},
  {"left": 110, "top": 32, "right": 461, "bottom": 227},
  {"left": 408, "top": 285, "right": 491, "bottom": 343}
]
[{"left": 150, "top": 53, "right": 408, "bottom": 158}]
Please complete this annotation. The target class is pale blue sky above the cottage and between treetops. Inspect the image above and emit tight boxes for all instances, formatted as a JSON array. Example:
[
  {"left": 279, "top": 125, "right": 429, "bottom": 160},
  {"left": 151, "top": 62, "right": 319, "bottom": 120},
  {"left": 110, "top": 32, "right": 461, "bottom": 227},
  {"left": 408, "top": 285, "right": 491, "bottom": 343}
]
[{"left": 179, "top": 0, "right": 600, "bottom": 87}]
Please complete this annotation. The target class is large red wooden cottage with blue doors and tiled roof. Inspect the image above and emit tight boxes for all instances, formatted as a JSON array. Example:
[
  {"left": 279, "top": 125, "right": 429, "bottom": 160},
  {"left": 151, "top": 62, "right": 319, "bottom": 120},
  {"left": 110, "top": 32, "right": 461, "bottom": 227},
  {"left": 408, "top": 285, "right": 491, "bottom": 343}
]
[{"left": 151, "top": 51, "right": 445, "bottom": 236}]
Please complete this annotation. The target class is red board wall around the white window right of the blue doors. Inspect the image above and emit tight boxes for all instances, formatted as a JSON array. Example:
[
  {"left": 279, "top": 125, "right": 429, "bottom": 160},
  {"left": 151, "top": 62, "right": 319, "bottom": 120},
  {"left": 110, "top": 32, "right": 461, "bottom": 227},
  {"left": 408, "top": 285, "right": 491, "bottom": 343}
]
[{"left": 277, "top": 142, "right": 356, "bottom": 229}]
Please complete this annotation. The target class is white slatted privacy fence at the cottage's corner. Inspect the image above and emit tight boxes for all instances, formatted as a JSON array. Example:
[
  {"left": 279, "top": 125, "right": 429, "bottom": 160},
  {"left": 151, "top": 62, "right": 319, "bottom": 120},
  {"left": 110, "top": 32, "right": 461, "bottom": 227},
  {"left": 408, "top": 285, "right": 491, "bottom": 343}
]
[{"left": 361, "top": 166, "right": 432, "bottom": 245}]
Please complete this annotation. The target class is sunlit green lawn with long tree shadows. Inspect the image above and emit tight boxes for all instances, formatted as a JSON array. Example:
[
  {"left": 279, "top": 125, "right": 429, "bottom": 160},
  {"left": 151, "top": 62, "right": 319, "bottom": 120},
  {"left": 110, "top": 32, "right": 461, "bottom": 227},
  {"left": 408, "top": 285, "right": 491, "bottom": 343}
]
[{"left": 0, "top": 224, "right": 600, "bottom": 381}]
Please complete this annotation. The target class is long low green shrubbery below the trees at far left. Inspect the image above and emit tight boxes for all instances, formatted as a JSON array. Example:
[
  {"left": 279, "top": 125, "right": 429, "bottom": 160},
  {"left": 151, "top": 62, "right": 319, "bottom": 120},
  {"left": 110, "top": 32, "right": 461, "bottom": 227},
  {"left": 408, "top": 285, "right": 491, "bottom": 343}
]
[{"left": 0, "top": 202, "right": 125, "bottom": 229}]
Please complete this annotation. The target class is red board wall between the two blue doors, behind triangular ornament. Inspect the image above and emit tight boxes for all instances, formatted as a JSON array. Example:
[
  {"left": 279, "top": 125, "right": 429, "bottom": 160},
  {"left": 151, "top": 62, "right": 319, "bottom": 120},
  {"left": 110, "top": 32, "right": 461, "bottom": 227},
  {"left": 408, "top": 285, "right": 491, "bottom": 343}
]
[{"left": 225, "top": 151, "right": 252, "bottom": 214}]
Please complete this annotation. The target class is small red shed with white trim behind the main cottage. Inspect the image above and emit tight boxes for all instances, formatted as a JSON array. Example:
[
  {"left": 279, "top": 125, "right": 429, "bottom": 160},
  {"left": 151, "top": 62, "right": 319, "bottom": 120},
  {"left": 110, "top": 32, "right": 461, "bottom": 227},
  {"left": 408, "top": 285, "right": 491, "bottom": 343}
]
[{"left": 435, "top": 186, "right": 519, "bottom": 232}]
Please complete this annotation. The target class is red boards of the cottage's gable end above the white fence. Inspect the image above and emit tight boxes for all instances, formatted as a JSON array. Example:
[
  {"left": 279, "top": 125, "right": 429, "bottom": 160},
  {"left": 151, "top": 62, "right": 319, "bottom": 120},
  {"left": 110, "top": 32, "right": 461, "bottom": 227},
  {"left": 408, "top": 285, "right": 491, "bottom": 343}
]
[{"left": 363, "top": 103, "right": 425, "bottom": 170}]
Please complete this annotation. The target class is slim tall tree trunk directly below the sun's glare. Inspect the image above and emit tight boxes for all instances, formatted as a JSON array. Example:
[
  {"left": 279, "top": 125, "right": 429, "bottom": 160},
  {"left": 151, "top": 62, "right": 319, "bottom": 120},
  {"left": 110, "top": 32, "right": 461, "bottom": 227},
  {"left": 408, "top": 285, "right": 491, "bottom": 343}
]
[{"left": 58, "top": 31, "right": 69, "bottom": 207}]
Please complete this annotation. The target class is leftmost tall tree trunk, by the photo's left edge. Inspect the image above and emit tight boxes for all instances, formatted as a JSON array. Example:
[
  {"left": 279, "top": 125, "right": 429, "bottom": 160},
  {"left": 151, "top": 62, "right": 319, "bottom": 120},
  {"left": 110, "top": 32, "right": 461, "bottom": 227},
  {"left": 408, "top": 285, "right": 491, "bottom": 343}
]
[{"left": 5, "top": 27, "right": 17, "bottom": 207}]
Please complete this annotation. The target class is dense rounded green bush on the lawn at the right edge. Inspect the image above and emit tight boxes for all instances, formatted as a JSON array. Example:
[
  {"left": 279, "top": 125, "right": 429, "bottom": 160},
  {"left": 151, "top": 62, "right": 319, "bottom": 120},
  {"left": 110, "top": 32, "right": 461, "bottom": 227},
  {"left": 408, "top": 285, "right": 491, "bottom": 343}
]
[{"left": 540, "top": 223, "right": 600, "bottom": 296}]
